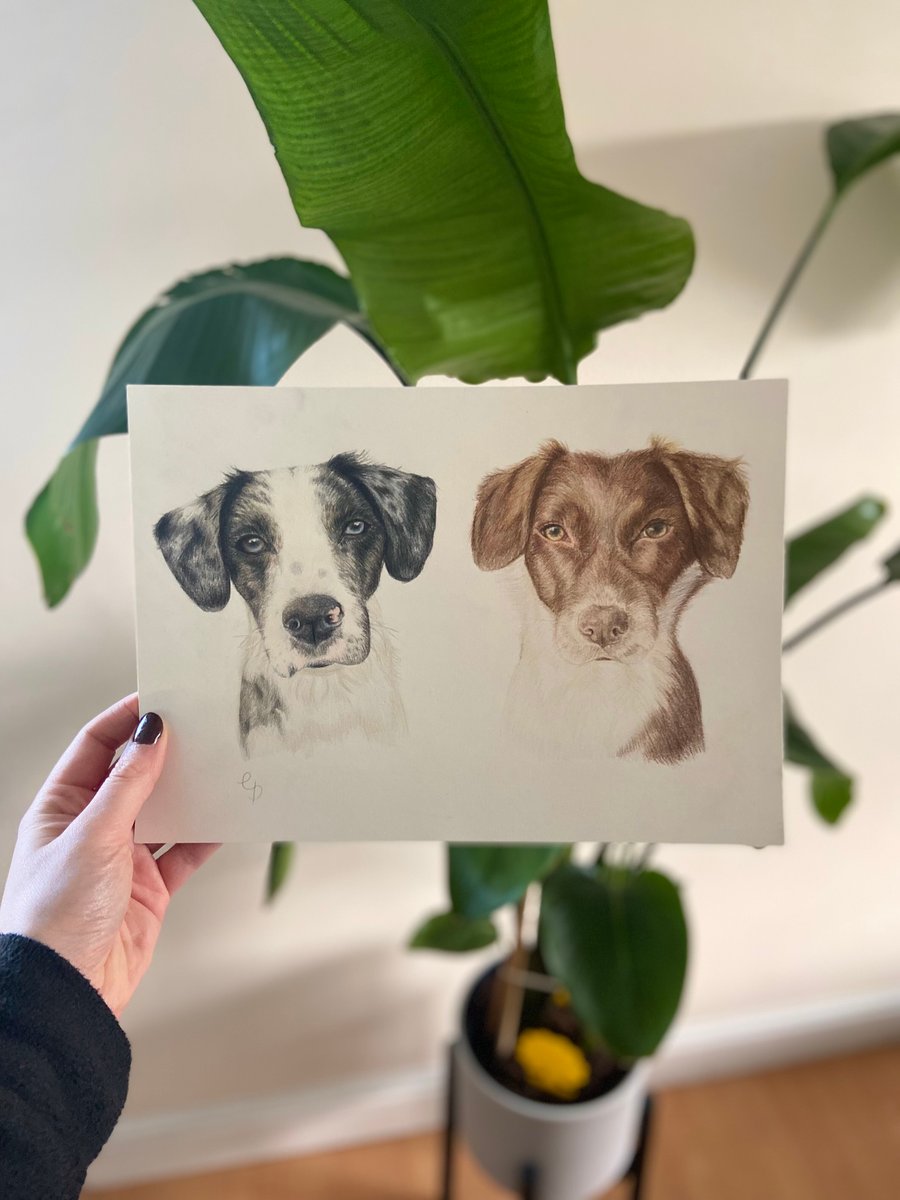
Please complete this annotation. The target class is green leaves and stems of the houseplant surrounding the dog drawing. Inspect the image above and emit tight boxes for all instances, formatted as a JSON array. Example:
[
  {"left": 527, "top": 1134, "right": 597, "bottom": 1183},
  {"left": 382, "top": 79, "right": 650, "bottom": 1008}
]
[{"left": 21, "top": 0, "right": 900, "bottom": 1195}]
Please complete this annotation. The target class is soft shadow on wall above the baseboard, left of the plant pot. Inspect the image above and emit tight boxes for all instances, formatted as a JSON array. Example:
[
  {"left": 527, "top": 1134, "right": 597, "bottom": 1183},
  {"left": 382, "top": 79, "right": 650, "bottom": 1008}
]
[{"left": 125, "top": 942, "right": 439, "bottom": 1114}]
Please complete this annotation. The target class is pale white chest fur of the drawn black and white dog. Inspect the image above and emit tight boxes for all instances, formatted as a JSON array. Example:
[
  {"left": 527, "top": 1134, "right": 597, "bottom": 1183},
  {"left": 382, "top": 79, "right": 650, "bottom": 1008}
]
[{"left": 244, "top": 601, "right": 407, "bottom": 758}]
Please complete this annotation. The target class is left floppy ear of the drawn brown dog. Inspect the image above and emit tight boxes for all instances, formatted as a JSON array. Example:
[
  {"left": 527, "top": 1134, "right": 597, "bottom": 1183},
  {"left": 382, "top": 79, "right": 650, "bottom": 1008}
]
[{"left": 472, "top": 442, "right": 568, "bottom": 571}]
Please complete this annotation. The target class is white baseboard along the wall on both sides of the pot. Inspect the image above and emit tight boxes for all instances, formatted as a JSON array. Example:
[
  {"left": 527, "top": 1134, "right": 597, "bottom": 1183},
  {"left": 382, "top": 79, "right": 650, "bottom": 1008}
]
[{"left": 88, "top": 990, "right": 900, "bottom": 1188}]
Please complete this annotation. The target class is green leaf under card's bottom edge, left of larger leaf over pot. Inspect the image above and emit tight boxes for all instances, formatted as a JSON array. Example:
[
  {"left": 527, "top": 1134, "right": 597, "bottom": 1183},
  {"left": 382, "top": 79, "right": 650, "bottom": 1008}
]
[{"left": 448, "top": 845, "right": 564, "bottom": 918}]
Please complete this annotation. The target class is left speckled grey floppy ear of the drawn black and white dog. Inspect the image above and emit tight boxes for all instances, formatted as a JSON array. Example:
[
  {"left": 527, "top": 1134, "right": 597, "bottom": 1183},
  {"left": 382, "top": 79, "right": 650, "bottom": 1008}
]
[{"left": 154, "top": 484, "right": 232, "bottom": 612}]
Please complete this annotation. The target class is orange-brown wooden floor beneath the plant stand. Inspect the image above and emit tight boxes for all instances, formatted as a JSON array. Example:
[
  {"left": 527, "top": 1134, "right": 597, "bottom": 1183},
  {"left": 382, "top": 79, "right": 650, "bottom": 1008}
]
[{"left": 85, "top": 1046, "right": 900, "bottom": 1200}]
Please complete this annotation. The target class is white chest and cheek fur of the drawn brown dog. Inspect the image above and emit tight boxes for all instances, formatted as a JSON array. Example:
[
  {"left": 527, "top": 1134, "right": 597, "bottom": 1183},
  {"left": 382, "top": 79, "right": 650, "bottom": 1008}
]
[{"left": 506, "top": 570, "right": 672, "bottom": 757}]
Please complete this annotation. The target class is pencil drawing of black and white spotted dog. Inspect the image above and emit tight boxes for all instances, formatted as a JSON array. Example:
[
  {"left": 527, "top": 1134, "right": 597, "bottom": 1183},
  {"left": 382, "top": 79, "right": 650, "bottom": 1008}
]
[{"left": 154, "top": 454, "right": 437, "bottom": 757}]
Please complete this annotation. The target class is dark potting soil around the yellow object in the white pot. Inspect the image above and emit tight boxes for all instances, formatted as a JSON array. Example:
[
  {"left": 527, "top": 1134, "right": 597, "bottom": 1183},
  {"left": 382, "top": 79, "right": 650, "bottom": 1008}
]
[{"left": 464, "top": 971, "right": 629, "bottom": 1104}]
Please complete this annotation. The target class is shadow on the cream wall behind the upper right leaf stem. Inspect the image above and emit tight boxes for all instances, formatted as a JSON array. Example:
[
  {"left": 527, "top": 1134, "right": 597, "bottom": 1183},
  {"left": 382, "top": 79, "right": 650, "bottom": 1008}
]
[{"left": 577, "top": 113, "right": 900, "bottom": 344}]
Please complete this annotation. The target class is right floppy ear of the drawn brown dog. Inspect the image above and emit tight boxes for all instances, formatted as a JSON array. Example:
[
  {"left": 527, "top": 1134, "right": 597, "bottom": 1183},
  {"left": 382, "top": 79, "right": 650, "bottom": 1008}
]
[{"left": 658, "top": 445, "right": 750, "bottom": 580}]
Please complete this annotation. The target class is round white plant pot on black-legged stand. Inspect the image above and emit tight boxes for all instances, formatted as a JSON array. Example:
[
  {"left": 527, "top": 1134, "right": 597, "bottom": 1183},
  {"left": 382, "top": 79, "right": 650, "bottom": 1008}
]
[{"left": 454, "top": 993, "right": 649, "bottom": 1200}]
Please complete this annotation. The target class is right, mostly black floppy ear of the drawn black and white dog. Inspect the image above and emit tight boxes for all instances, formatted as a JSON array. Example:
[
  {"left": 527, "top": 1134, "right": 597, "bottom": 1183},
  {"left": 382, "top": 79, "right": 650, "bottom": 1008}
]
[{"left": 329, "top": 454, "right": 437, "bottom": 583}]
